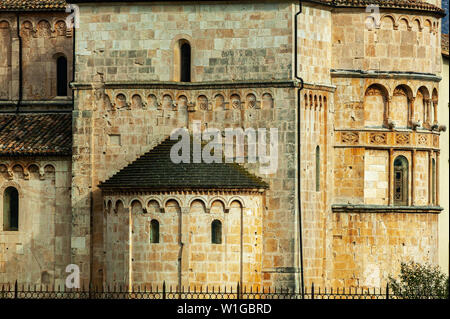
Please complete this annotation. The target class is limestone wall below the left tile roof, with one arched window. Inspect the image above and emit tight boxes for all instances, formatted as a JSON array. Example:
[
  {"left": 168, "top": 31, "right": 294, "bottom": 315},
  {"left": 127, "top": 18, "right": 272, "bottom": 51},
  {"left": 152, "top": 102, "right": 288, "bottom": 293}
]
[{"left": 0, "top": 158, "right": 71, "bottom": 285}]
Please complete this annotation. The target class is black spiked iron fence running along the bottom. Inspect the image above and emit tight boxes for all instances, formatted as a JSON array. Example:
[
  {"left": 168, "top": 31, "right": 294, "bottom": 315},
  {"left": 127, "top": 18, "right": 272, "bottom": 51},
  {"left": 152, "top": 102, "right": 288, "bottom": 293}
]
[{"left": 0, "top": 282, "right": 443, "bottom": 300}]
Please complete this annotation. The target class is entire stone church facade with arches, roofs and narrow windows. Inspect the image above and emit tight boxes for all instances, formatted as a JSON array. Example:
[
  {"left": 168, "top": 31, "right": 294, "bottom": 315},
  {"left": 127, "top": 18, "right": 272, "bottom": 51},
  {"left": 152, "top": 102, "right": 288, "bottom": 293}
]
[{"left": 0, "top": 0, "right": 445, "bottom": 287}]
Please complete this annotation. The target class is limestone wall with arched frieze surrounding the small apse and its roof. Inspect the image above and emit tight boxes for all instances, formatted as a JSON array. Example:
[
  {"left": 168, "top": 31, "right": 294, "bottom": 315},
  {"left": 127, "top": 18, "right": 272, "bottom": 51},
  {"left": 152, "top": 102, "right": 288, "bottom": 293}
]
[{"left": 72, "top": 82, "right": 297, "bottom": 283}]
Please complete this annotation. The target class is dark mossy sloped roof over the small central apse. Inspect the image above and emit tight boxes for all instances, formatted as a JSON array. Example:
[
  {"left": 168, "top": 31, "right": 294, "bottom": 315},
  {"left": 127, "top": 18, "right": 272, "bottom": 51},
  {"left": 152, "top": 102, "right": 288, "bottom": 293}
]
[{"left": 99, "top": 138, "right": 268, "bottom": 191}]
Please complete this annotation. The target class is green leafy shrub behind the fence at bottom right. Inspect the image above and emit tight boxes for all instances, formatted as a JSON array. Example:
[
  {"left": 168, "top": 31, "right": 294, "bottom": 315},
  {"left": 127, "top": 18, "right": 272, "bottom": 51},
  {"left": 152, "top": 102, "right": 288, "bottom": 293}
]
[{"left": 389, "top": 262, "right": 449, "bottom": 299}]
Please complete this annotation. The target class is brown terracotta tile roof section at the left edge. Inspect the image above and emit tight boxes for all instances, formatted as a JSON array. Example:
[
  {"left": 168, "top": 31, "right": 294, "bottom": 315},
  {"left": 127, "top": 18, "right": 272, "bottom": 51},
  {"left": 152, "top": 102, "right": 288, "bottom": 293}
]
[{"left": 0, "top": 114, "right": 72, "bottom": 156}]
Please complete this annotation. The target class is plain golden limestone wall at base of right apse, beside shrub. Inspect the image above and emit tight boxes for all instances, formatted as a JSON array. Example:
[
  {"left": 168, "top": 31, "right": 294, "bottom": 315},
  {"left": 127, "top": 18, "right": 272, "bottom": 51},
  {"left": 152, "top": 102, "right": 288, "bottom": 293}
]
[{"left": 330, "top": 212, "right": 438, "bottom": 288}]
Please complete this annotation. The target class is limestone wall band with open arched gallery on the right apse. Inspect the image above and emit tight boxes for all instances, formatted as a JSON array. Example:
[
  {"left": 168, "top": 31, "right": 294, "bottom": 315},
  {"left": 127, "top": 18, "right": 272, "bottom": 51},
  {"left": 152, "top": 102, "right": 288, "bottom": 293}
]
[{"left": 332, "top": 77, "right": 439, "bottom": 131}]
